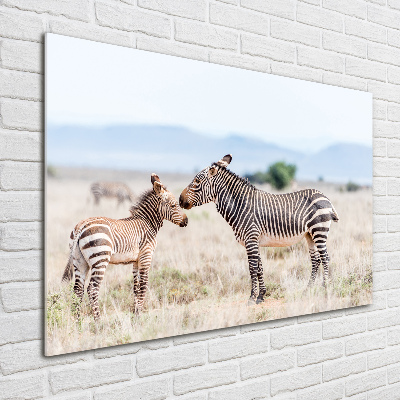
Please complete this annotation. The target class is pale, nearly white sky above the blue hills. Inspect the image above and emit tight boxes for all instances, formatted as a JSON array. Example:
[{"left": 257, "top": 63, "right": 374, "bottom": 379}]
[{"left": 46, "top": 34, "right": 372, "bottom": 151}]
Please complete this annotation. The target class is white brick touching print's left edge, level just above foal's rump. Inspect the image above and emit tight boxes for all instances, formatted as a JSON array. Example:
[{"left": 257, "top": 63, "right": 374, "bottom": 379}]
[{"left": 0, "top": 191, "right": 43, "bottom": 222}]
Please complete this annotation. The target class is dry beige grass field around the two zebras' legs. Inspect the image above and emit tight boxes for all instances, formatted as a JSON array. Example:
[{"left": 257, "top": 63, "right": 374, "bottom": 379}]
[{"left": 46, "top": 172, "right": 372, "bottom": 355}]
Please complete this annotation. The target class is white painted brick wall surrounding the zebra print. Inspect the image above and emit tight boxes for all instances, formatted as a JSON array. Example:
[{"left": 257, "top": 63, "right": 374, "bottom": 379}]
[{"left": 0, "top": 0, "right": 400, "bottom": 400}]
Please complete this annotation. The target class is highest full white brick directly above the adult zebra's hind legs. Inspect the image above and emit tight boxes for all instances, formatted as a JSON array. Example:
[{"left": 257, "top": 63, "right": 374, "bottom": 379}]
[{"left": 297, "top": 3, "right": 343, "bottom": 32}]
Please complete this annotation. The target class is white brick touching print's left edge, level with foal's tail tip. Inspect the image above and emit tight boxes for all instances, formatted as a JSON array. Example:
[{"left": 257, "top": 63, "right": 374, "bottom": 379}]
[{"left": 0, "top": 250, "right": 43, "bottom": 283}]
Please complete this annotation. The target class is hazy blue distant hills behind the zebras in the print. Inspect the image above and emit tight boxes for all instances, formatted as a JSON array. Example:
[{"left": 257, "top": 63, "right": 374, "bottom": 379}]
[{"left": 47, "top": 125, "right": 372, "bottom": 184}]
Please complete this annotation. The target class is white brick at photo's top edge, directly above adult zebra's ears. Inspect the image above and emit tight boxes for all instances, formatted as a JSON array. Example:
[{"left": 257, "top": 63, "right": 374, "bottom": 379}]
[{"left": 210, "top": 3, "right": 269, "bottom": 36}]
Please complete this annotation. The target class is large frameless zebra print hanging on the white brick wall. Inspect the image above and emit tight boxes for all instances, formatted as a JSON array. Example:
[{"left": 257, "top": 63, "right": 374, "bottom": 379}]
[{"left": 45, "top": 34, "right": 372, "bottom": 355}]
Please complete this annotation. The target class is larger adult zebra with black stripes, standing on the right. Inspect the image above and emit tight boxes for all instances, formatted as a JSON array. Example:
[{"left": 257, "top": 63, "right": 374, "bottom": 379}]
[{"left": 179, "top": 154, "right": 339, "bottom": 304}]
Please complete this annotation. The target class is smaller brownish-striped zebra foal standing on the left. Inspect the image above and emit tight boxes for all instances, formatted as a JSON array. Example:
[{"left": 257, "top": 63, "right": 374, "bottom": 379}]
[{"left": 62, "top": 173, "right": 188, "bottom": 320}]
